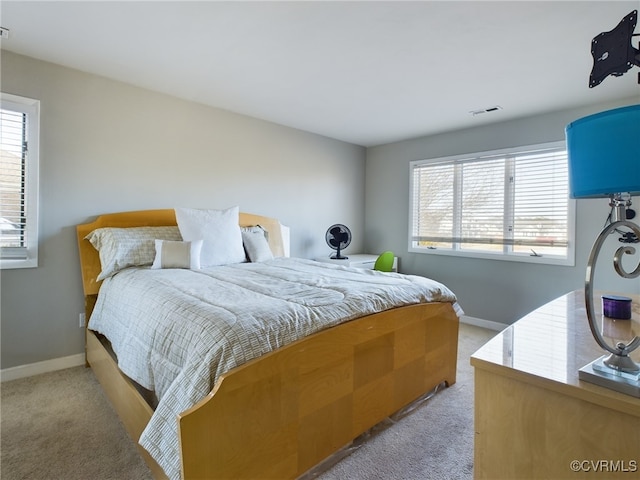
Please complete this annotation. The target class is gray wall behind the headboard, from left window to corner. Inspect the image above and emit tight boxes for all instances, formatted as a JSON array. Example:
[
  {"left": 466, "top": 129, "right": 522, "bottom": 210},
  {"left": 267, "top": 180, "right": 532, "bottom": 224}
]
[{"left": 0, "top": 51, "right": 365, "bottom": 369}]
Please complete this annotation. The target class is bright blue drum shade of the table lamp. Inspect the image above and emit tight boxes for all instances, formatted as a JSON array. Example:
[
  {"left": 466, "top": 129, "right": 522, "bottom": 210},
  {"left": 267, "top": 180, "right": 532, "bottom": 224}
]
[{"left": 566, "top": 105, "right": 640, "bottom": 198}]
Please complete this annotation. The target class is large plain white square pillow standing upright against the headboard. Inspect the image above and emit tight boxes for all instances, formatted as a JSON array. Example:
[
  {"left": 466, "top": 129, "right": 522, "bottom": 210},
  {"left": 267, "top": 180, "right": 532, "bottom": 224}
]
[{"left": 175, "top": 206, "right": 246, "bottom": 268}]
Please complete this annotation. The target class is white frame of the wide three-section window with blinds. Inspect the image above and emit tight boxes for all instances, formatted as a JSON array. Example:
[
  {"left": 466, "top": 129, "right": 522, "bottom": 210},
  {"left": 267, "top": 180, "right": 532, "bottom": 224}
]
[{"left": 408, "top": 141, "right": 576, "bottom": 266}]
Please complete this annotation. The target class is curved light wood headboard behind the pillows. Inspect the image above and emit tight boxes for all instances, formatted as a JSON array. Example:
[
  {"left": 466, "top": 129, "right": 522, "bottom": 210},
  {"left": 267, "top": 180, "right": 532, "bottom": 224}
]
[{"left": 76, "top": 209, "right": 285, "bottom": 297}]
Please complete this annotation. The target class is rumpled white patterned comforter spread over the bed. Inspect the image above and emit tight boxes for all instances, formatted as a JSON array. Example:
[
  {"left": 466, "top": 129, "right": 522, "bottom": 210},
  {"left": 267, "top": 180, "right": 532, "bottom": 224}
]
[{"left": 89, "top": 258, "right": 461, "bottom": 479}]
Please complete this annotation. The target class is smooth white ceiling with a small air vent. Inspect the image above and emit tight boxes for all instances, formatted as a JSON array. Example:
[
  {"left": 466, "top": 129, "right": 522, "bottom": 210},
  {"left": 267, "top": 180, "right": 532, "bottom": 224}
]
[{"left": 0, "top": 0, "right": 640, "bottom": 146}]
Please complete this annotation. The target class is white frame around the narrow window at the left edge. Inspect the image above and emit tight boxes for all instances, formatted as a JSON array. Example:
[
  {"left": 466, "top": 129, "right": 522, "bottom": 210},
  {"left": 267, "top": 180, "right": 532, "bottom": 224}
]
[{"left": 0, "top": 92, "right": 40, "bottom": 269}]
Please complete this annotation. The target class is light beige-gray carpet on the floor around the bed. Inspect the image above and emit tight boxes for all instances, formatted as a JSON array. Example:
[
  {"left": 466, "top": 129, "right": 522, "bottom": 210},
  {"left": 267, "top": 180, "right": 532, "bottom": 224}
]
[{"left": 0, "top": 324, "right": 496, "bottom": 480}]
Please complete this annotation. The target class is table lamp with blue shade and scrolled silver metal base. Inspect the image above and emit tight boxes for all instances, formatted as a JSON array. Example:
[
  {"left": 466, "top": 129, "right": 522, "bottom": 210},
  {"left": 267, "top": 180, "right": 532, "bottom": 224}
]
[{"left": 566, "top": 105, "right": 640, "bottom": 397}]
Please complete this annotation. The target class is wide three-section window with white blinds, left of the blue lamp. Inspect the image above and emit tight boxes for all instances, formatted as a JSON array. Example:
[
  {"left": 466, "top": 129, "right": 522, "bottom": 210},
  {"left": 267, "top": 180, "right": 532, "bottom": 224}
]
[{"left": 409, "top": 142, "right": 575, "bottom": 265}]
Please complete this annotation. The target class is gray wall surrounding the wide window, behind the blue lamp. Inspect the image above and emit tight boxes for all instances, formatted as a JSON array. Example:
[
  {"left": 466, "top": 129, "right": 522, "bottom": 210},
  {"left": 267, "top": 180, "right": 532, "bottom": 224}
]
[{"left": 365, "top": 97, "right": 640, "bottom": 324}]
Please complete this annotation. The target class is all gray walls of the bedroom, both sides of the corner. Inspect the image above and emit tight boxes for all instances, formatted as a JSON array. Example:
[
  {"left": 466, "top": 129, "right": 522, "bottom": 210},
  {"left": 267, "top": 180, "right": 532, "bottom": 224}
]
[{"left": 0, "top": 47, "right": 640, "bottom": 369}]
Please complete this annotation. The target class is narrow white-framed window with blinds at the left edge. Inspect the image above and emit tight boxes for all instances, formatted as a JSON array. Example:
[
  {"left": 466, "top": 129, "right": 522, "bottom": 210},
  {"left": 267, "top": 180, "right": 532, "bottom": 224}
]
[{"left": 0, "top": 93, "right": 40, "bottom": 268}]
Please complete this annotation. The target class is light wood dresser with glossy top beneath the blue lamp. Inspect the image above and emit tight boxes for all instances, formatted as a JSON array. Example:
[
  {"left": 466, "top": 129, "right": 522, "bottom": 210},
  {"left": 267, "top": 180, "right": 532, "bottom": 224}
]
[{"left": 471, "top": 291, "right": 640, "bottom": 480}]
